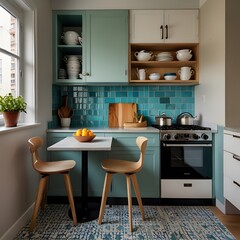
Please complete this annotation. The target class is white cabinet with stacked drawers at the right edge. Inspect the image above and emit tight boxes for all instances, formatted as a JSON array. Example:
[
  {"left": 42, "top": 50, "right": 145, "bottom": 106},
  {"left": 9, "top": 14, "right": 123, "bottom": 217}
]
[{"left": 223, "top": 130, "right": 240, "bottom": 210}]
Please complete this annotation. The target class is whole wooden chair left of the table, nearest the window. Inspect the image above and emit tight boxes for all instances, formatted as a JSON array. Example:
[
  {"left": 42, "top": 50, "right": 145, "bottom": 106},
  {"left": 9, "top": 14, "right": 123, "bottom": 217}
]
[{"left": 28, "top": 137, "right": 77, "bottom": 231}]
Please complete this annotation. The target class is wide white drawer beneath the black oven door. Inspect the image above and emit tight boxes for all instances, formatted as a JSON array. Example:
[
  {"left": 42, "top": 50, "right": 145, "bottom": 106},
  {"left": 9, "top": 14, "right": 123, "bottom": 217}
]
[{"left": 161, "top": 179, "right": 212, "bottom": 198}]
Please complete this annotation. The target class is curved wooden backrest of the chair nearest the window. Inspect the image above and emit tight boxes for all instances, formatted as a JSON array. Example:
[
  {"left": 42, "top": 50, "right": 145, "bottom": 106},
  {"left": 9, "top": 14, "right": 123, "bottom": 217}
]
[{"left": 28, "top": 137, "right": 43, "bottom": 172}]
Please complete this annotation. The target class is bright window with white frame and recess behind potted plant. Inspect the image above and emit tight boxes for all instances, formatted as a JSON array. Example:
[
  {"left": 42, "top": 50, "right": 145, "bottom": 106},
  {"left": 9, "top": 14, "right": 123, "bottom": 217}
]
[{"left": 0, "top": 0, "right": 36, "bottom": 126}]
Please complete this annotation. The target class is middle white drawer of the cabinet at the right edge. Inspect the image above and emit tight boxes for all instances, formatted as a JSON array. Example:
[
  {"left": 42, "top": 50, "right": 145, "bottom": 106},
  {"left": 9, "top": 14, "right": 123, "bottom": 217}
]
[{"left": 223, "top": 151, "right": 240, "bottom": 183}]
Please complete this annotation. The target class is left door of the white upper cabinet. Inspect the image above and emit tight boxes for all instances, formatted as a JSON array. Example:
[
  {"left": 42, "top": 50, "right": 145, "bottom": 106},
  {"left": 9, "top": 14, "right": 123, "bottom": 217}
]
[{"left": 130, "top": 10, "right": 164, "bottom": 43}]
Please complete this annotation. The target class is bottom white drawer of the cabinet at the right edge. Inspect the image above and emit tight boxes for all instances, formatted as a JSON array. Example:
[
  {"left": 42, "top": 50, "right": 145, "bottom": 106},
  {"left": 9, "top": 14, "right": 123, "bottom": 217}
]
[{"left": 224, "top": 176, "right": 240, "bottom": 210}]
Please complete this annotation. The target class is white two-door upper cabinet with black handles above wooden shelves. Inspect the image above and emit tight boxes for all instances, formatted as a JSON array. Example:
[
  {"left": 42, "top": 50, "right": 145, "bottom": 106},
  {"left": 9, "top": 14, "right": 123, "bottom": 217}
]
[{"left": 130, "top": 10, "right": 198, "bottom": 43}]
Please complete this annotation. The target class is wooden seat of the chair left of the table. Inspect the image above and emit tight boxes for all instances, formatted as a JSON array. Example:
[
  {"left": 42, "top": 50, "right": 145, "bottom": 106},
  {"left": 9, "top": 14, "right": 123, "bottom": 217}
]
[{"left": 35, "top": 160, "right": 76, "bottom": 174}]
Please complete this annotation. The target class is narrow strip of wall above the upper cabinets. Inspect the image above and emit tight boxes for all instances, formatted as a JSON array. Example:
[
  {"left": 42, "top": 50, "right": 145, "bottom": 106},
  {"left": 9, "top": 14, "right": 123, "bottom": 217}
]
[{"left": 52, "top": 0, "right": 199, "bottom": 9}]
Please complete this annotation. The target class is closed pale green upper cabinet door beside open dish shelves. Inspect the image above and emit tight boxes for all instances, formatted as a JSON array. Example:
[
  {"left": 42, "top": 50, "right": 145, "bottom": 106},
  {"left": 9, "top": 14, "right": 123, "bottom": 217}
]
[{"left": 85, "top": 10, "right": 128, "bottom": 83}]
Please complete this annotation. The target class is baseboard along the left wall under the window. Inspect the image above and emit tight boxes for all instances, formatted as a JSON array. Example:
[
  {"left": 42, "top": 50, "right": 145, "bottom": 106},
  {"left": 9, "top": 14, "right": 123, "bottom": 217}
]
[{"left": 0, "top": 203, "right": 34, "bottom": 240}]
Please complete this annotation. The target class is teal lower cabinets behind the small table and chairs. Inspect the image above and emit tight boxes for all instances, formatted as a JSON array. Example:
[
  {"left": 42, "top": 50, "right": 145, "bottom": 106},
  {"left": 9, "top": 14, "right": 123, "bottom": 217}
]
[{"left": 47, "top": 132, "right": 160, "bottom": 198}]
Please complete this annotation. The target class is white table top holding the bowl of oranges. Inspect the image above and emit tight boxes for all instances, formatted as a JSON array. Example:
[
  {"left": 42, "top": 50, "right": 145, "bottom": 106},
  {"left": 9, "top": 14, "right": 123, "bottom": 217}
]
[{"left": 47, "top": 137, "right": 112, "bottom": 151}]
